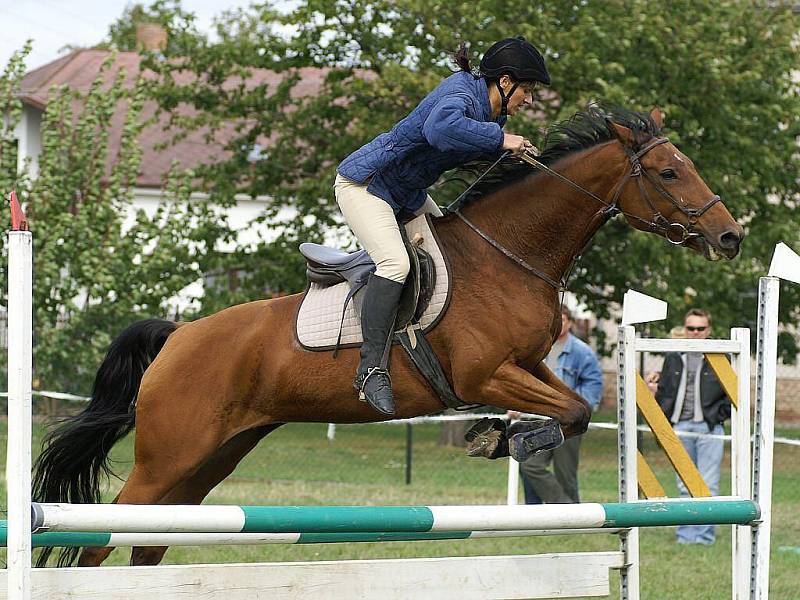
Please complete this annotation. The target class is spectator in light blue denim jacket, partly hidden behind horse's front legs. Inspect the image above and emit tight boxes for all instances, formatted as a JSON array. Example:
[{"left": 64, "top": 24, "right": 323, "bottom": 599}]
[{"left": 511, "top": 306, "right": 603, "bottom": 504}]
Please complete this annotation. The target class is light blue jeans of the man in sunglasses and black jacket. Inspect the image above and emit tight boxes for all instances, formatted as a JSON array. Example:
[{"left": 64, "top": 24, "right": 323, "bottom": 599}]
[{"left": 673, "top": 421, "right": 725, "bottom": 544}]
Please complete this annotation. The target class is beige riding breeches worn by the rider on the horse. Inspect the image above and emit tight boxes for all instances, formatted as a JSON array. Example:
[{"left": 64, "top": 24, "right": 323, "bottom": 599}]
[{"left": 333, "top": 173, "right": 442, "bottom": 283}]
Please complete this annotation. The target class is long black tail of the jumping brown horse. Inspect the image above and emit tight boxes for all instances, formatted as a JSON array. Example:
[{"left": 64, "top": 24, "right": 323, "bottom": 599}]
[{"left": 32, "top": 319, "right": 178, "bottom": 567}]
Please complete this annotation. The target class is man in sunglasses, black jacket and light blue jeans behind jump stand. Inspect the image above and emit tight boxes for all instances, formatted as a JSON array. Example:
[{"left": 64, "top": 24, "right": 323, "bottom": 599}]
[{"left": 647, "top": 308, "right": 731, "bottom": 544}]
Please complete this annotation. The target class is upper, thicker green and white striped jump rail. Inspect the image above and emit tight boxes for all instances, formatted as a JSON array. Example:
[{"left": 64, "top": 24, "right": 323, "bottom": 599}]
[{"left": 32, "top": 498, "right": 759, "bottom": 534}]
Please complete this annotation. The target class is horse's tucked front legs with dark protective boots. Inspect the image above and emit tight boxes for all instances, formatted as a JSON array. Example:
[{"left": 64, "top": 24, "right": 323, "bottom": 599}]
[{"left": 462, "top": 361, "right": 591, "bottom": 458}]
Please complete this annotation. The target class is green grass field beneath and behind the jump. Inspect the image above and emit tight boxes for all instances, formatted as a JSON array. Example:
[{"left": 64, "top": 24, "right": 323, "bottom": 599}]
[{"left": 0, "top": 415, "right": 800, "bottom": 600}]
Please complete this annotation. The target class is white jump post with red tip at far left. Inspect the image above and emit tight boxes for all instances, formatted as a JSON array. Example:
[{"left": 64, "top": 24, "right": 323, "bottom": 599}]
[{"left": 6, "top": 192, "right": 33, "bottom": 600}]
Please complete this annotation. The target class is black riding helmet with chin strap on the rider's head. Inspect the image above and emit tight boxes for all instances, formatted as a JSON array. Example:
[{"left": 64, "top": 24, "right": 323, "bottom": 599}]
[{"left": 480, "top": 36, "right": 550, "bottom": 116}]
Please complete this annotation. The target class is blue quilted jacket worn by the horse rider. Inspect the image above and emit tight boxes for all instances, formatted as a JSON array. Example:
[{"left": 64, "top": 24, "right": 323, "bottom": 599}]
[{"left": 338, "top": 71, "right": 505, "bottom": 214}]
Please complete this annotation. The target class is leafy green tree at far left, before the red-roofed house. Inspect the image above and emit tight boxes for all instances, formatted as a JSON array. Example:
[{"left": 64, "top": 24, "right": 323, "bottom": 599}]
[{"left": 0, "top": 54, "right": 230, "bottom": 394}]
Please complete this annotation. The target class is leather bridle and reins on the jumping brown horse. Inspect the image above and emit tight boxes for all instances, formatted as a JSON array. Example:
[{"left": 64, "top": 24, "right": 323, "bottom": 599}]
[{"left": 446, "top": 137, "right": 720, "bottom": 291}]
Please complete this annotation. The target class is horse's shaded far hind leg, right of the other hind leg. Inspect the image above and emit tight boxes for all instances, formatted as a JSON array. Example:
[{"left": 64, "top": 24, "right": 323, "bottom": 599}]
[{"left": 130, "top": 423, "right": 282, "bottom": 566}]
